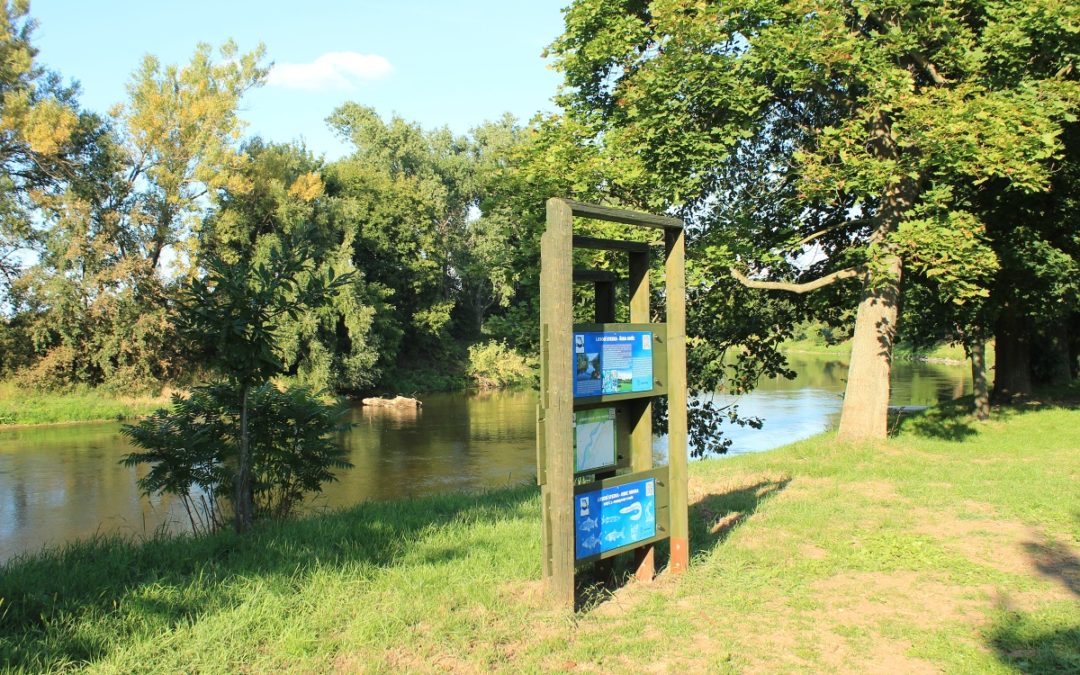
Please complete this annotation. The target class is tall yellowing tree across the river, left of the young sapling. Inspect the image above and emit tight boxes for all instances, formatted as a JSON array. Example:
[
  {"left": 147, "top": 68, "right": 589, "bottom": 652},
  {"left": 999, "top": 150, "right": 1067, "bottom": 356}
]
[{"left": 11, "top": 43, "right": 265, "bottom": 389}]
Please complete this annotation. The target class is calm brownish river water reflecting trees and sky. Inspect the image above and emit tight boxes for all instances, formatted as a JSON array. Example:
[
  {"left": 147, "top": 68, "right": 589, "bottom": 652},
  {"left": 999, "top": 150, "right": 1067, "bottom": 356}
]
[{"left": 0, "top": 354, "right": 971, "bottom": 562}]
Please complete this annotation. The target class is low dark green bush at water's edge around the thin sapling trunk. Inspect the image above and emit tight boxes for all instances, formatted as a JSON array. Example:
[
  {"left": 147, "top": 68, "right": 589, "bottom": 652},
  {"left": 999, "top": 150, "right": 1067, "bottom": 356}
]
[{"left": 122, "top": 383, "right": 352, "bottom": 531}]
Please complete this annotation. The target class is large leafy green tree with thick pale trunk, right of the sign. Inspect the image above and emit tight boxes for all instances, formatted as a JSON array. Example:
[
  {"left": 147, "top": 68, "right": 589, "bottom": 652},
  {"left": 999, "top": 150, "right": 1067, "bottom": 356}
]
[{"left": 551, "top": 0, "right": 1080, "bottom": 438}]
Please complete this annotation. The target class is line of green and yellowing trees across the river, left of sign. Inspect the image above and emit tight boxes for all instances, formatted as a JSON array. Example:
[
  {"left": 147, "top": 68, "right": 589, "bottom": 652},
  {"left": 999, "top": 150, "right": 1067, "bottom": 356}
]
[{"left": 0, "top": 2, "right": 532, "bottom": 392}]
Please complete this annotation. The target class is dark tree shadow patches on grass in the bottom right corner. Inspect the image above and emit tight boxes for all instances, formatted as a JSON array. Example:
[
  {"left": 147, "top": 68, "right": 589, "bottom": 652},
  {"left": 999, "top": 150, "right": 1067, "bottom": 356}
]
[{"left": 988, "top": 520, "right": 1080, "bottom": 673}]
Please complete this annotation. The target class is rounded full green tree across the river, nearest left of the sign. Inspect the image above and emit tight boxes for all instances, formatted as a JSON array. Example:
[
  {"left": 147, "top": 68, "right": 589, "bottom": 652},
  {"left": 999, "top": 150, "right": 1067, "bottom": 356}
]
[{"left": 324, "top": 104, "right": 528, "bottom": 379}]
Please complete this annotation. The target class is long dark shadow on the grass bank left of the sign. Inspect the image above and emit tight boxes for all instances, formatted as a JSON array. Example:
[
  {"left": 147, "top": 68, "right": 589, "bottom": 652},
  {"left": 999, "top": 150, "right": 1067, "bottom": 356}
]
[{"left": 0, "top": 486, "right": 537, "bottom": 672}]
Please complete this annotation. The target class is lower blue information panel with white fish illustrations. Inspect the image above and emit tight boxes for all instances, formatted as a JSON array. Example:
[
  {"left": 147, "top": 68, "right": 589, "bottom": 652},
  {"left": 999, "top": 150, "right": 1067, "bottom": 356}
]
[{"left": 573, "top": 478, "right": 657, "bottom": 561}]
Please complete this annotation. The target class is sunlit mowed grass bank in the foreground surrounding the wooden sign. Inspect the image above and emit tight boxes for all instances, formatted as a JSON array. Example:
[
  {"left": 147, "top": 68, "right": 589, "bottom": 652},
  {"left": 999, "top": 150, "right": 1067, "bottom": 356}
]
[{"left": 0, "top": 393, "right": 1080, "bottom": 673}]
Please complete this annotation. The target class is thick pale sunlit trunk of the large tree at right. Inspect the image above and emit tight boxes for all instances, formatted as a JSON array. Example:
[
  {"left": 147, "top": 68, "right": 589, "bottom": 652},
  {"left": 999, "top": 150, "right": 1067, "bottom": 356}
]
[{"left": 837, "top": 256, "right": 903, "bottom": 441}]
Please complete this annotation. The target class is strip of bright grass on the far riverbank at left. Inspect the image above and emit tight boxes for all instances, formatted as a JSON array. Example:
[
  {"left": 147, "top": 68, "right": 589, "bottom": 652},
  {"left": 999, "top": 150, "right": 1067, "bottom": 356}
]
[{"left": 0, "top": 382, "right": 168, "bottom": 429}]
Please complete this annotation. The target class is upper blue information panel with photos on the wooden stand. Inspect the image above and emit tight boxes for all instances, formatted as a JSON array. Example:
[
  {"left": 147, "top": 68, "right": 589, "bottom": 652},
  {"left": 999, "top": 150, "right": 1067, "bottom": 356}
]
[{"left": 573, "top": 330, "right": 652, "bottom": 397}]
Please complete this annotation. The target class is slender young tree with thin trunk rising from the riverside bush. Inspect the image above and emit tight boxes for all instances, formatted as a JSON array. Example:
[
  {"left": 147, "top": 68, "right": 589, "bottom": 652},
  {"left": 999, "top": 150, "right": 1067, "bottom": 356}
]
[{"left": 180, "top": 231, "right": 352, "bottom": 532}]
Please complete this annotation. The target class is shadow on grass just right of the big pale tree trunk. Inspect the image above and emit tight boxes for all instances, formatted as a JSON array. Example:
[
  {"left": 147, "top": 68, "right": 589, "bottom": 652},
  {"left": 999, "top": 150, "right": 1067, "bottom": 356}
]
[{"left": 889, "top": 387, "right": 1080, "bottom": 442}]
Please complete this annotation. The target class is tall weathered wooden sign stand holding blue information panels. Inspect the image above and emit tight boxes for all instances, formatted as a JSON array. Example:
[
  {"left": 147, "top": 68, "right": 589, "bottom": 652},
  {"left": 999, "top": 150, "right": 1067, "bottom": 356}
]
[{"left": 537, "top": 198, "right": 689, "bottom": 607}]
